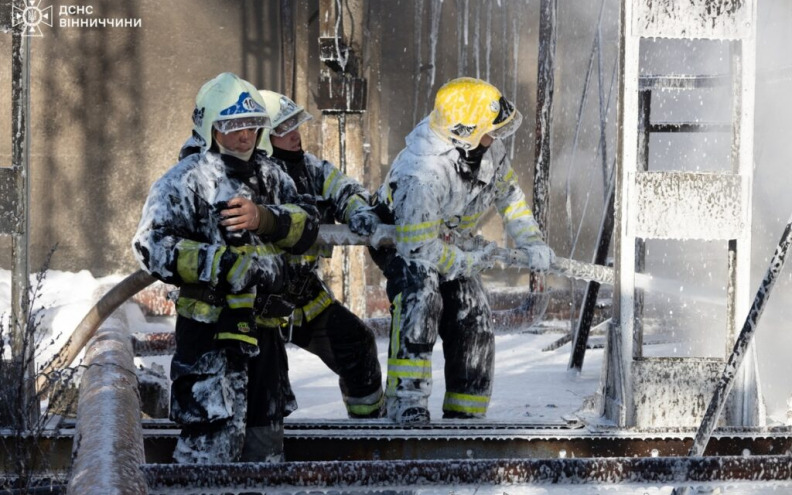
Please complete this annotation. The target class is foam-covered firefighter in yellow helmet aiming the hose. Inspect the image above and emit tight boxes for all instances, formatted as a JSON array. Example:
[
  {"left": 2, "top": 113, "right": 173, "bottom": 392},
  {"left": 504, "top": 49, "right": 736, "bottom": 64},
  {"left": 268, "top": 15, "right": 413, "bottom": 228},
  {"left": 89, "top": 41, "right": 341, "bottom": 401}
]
[{"left": 373, "top": 77, "right": 554, "bottom": 423}]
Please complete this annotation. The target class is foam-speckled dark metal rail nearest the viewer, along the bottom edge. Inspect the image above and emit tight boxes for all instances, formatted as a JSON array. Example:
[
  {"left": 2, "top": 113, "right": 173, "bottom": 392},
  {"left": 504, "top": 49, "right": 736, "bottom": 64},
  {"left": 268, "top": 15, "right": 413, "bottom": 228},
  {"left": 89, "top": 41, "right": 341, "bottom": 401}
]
[{"left": 142, "top": 456, "right": 792, "bottom": 494}]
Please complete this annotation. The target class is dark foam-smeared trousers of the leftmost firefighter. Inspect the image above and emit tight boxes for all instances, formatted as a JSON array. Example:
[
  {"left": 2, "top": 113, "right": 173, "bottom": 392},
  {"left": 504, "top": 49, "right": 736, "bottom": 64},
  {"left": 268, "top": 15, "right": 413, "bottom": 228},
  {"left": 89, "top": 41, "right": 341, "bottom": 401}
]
[{"left": 170, "top": 316, "right": 296, "bottom": 464}]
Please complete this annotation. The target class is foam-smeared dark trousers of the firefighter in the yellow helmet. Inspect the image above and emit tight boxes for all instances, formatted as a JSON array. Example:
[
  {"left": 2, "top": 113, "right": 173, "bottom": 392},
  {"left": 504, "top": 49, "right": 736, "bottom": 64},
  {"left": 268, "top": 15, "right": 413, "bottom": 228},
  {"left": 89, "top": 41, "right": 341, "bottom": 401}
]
[{"left": 384, "top": 256, "right": 495, "bottom": 419}]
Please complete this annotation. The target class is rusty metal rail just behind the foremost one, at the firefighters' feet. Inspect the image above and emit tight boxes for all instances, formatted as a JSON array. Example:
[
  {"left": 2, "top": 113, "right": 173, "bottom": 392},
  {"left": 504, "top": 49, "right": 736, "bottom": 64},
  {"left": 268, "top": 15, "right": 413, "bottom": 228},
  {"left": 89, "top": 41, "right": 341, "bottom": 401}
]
[{"left": 128, "top": 419, "right": 792, "bottom": 464}]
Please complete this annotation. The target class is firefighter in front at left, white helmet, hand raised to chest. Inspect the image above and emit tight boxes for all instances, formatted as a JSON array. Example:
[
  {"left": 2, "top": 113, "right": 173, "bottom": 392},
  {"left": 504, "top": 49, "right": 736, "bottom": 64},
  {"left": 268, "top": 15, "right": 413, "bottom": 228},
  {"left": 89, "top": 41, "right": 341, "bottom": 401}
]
[{"left": 133, "top": 73, "right": 318, "bottom": 463}]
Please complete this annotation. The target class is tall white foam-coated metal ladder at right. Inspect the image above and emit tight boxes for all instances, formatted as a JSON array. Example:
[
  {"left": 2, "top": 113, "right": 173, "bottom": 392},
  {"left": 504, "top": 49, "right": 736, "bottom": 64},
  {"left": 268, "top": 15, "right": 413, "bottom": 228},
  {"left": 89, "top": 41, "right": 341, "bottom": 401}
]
[{"left": 601, "top": 0, "right": 764, "bottom": 427}]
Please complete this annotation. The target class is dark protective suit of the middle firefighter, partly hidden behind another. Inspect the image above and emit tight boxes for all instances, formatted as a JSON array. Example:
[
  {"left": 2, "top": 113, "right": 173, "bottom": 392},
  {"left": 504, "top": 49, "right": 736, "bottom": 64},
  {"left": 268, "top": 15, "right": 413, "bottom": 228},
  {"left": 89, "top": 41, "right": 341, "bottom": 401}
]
[{"left": 272, "top": 148, "right": 382, "bottom": 417}]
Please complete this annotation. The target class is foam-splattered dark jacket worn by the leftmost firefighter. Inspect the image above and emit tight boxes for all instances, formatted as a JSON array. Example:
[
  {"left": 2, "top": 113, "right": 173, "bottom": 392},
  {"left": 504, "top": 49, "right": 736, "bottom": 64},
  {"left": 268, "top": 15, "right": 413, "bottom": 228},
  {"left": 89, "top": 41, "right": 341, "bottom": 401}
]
[{"left": 132, "top": 151, "right": 315, "bottom": 322}]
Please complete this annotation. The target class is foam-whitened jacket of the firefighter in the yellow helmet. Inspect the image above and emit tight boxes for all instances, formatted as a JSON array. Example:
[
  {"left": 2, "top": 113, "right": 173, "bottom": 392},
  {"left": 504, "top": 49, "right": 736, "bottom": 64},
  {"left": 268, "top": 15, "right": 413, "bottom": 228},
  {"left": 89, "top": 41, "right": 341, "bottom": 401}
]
[{"left": 377, "top": 118, "right": 542, "bottom": 280}]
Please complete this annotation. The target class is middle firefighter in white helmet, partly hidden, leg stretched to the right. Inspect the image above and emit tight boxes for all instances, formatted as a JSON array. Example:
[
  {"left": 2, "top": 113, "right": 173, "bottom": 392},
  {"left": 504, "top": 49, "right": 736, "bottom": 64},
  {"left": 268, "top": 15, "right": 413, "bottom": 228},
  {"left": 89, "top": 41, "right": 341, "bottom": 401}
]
[{"left": 179, "top": 90, "right": 384, "bottom": 418}]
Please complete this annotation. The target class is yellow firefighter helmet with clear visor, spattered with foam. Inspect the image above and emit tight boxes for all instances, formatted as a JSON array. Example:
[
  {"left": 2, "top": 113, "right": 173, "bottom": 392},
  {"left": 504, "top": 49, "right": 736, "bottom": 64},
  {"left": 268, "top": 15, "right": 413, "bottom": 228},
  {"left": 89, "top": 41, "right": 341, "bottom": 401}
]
[{"left": 429, "top": 77, "right": 522, "bottom": 150}]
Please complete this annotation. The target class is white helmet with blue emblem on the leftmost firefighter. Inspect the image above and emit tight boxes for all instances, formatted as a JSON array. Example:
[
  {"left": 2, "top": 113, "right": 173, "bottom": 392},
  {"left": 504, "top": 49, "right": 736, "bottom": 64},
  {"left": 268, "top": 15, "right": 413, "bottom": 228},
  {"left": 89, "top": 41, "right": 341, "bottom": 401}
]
[{"left": 193, "top": 72, "right": 272, "bottom": 156}]
